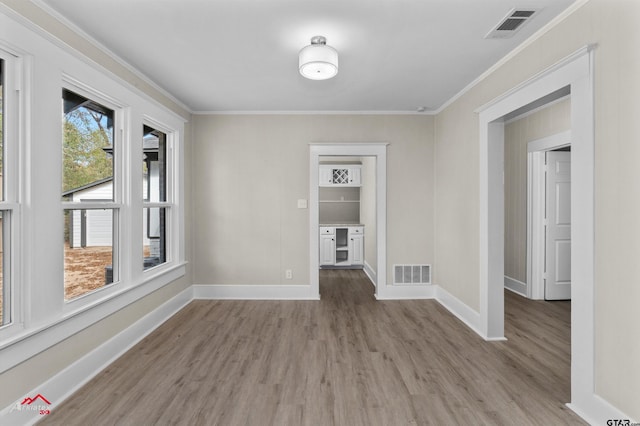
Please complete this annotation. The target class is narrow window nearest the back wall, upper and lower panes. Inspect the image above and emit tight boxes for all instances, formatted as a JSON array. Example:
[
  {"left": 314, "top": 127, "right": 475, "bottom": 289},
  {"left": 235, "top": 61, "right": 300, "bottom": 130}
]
[{"left": 142, "top": 126, "right": 170, "bottom": 270}]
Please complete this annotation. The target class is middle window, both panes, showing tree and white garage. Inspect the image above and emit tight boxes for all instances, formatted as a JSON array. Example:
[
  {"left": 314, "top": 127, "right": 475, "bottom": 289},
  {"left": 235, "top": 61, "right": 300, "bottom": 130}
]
[{"left": 62, "top": 89, "right": 119, "bottom": 300}]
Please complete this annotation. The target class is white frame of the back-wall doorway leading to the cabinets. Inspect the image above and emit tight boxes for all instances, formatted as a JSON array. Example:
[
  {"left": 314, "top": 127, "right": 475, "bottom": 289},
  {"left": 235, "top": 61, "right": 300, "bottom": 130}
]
[{"left": 309, "top": 143, "right": 388, "bottom": 299}]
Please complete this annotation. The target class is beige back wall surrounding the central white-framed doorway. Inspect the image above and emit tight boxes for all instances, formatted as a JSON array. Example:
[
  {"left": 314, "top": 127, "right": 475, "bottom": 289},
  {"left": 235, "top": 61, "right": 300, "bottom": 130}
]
[{"left": 192, "top": 115, "right": 434, "bottom": 285}]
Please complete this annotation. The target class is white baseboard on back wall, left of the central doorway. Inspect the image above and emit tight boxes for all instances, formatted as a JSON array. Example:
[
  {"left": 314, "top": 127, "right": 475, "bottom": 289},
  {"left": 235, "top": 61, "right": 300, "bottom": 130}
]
[{"left": 193, "top": 284, "right": 318, "bottom": 300}]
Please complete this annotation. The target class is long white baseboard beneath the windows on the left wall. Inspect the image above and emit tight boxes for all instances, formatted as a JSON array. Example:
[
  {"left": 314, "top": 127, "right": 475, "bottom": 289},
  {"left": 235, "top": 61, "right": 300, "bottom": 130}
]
[{"left": 0, "top": 287, "right": 193, "bottom": 425}]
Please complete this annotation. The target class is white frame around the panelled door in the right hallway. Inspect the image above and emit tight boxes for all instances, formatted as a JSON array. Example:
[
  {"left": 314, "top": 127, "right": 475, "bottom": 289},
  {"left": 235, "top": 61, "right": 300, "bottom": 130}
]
[{"left": 526, "top": 130, "right": 571, "bottom": 300}]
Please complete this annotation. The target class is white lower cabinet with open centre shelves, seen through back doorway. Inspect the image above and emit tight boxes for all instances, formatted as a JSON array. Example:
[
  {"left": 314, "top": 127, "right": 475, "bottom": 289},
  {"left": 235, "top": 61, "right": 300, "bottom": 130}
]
[{"left": 320, "top": 226, "right": 364, "bottom": 266}]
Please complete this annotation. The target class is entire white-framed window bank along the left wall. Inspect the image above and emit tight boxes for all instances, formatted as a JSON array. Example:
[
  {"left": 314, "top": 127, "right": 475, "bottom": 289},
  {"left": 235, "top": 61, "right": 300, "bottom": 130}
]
[{"left": 0, "top": 19, "right": 186, "bottom": 380}]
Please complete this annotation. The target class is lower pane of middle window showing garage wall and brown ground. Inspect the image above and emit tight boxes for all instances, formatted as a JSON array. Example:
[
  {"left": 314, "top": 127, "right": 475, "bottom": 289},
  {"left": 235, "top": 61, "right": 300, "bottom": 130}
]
[{"left": 64, "top": 209, "right": 117, "bottom": 300}]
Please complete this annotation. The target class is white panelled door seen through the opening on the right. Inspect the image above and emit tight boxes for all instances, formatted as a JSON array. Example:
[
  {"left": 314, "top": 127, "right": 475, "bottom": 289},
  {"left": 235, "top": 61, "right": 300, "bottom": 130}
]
[{"left": 544, "top": 151, "right": 571, "bottom": 300}]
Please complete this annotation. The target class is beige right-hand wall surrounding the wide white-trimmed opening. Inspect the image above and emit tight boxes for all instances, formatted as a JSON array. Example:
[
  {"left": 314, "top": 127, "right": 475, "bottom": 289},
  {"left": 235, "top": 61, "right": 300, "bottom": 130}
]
[{"left": 434, "top": 0, "right": 640, "bottom": 419}]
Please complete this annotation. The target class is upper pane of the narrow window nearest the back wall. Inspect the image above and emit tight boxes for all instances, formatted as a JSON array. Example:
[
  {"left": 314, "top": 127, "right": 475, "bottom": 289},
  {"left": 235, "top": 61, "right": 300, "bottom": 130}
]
[{"left": 142, "top": 126, "right": 167, "bottom": 202}]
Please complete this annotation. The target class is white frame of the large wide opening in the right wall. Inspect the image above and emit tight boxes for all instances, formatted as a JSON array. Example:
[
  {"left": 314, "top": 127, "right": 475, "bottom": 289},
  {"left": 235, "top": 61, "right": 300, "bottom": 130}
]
[{"left": 477, "top": 46, "right": 606, "bottom": 419}]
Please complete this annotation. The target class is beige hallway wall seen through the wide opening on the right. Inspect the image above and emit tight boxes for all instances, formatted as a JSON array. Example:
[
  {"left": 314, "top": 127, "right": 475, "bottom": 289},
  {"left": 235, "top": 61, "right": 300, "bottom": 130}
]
[{"left": 504, "top": 98, "right": 571, "bottom": 283}]
